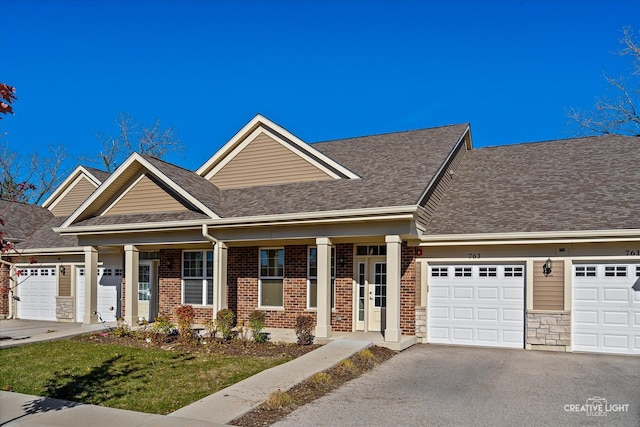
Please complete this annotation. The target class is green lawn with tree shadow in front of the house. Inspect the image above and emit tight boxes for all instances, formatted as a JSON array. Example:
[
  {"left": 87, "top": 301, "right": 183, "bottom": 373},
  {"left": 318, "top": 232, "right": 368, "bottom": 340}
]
[{"left": 0, "top": 340, "right": 289, "bottom": 414}]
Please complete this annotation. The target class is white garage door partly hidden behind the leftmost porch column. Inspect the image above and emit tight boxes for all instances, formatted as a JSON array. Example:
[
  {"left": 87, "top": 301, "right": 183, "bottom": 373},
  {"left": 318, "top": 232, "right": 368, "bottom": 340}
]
[{"left": 76, "top": 267, "right": 122, "bottom": 322}]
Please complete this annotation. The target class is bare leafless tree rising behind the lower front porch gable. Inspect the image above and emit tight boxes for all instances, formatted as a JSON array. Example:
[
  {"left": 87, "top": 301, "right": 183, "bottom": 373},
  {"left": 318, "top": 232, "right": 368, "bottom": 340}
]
[{"left": 97, "top": 113, "right": 183, "bottom": 172}]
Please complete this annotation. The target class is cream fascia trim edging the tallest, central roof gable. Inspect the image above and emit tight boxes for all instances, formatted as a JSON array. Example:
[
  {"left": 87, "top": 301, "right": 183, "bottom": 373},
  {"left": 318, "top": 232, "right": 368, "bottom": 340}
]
[{"left": 196, "top": 114, "right": 360, "bottom": 179}]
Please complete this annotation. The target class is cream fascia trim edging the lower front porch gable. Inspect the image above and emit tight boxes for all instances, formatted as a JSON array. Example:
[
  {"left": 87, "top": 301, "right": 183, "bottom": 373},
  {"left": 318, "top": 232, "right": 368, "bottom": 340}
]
[{"left": 58, "top": 153, "right": 219, "bottom": 230}]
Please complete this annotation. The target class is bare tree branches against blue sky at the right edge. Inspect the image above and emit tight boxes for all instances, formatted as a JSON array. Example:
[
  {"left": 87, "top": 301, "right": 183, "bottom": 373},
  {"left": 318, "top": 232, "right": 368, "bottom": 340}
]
[{"left": 567, "top": 27, "right": 640, "bottom": 136}]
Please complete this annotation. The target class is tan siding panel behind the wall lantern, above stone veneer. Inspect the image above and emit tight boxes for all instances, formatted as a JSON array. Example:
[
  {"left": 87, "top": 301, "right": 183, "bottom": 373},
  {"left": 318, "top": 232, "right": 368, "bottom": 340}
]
[{"left": 533, "top": 261, "right": 564, "bottom": 310}]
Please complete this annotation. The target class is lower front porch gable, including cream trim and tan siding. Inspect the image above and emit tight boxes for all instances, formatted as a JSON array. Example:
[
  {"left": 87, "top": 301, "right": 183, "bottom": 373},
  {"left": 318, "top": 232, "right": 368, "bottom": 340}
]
[{"left": 61, "top": 153, "right": 219, "bottom": 228}]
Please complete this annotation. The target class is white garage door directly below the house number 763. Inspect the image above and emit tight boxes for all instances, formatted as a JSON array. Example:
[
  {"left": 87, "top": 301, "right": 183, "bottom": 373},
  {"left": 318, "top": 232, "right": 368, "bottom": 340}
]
[{"left": 428, "top": 265, "right": 524, "bottom": 348}]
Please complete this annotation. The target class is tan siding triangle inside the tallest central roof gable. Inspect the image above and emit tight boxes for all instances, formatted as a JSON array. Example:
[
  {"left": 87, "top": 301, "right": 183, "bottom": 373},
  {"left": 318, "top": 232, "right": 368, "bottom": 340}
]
[{"left": 211, "top": 133, "right": 334, "bottom": 189}]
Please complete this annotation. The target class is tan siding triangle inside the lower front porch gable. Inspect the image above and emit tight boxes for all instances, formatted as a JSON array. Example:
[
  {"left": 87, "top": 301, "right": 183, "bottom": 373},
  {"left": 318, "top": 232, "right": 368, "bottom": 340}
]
[{"left": 104, "top": 175, "right": 187, "bottom": 215}]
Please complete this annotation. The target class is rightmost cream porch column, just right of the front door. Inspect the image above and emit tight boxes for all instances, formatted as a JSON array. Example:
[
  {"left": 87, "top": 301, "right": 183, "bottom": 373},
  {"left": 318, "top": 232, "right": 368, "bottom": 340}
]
[{"left": 384, "top": 236, "right": 402, "bottom": 342}]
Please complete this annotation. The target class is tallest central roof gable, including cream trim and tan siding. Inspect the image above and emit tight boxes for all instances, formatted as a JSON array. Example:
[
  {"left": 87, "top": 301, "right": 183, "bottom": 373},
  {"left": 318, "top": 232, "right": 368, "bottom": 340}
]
[{"left": 196, "top": 114, "right": 360, "bottom": 189}]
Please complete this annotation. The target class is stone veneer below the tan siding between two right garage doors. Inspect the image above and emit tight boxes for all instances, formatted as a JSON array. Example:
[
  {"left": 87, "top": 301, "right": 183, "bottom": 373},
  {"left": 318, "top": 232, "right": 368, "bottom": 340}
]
[{"left": 526, "top": 310, "right": 571, "bottom": 351}]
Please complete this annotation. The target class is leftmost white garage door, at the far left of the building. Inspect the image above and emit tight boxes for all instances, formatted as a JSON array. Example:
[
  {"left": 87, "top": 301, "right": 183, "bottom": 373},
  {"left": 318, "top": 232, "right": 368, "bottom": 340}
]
[{"left": 17, "top": 267, "right": 57, "bottom": 320}]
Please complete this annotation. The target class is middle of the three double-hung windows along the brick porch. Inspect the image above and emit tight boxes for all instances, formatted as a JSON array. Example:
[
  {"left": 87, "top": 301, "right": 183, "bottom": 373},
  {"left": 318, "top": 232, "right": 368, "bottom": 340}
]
[{"left": 258, "top": 248, "right": 284, "bottom": 307}]
